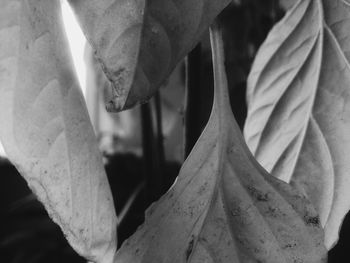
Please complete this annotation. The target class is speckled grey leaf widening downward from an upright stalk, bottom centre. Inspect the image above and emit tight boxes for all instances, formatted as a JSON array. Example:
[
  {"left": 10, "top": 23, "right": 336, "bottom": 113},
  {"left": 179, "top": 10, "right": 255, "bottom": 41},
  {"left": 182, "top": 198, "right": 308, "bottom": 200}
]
[{"left": 115, "top": 21, "right": 327, "bottom": 263}]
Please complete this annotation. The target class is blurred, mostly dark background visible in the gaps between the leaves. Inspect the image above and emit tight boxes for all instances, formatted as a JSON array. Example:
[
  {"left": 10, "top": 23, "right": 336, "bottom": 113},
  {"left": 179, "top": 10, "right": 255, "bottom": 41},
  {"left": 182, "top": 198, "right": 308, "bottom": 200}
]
[{"left": 0, "top": 0, "right": 350, "bottom": 263}]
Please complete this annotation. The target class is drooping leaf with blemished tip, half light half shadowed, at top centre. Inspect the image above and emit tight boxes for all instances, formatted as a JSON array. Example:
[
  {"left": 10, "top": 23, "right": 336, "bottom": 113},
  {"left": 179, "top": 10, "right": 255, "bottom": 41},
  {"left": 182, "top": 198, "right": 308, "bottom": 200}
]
[{"left": 69, "top": 0, "right": 230, "bottom": 111}]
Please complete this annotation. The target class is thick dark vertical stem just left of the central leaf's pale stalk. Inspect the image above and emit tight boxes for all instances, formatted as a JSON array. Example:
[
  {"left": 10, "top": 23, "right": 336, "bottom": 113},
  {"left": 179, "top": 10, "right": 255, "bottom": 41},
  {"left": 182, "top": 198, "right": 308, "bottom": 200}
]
[{"left": 184, "top": 44, "right": 202, "bottom": 158}]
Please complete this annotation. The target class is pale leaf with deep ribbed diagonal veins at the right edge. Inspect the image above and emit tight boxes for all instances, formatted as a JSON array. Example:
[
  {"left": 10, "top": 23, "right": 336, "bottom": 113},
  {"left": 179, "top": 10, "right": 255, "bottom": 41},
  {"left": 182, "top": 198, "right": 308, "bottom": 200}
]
[{"left": 244, "top": 0, "right": 350, "bottom": 248}]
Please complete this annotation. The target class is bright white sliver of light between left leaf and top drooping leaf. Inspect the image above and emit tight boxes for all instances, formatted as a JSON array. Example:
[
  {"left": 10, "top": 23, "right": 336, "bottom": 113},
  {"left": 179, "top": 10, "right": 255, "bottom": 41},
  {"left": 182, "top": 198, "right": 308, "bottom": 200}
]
[{"left": 61, "top": 0, "right": 86, "bottom": 95}]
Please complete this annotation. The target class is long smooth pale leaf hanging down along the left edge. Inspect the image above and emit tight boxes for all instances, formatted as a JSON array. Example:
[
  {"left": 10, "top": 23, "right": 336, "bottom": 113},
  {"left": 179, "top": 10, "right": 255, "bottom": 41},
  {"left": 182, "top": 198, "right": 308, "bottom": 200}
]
[{"left": 0, "top": 0, "right": 116, "bottom": 262}]
